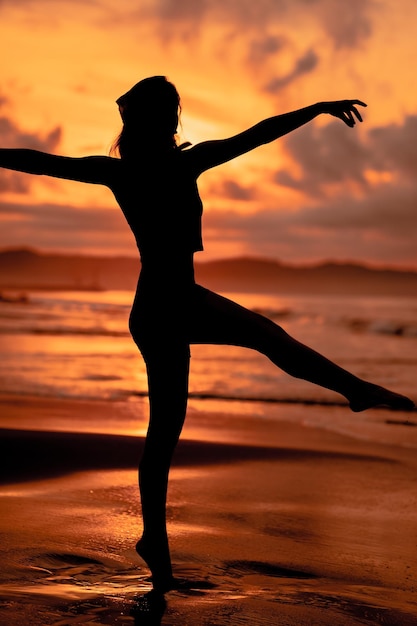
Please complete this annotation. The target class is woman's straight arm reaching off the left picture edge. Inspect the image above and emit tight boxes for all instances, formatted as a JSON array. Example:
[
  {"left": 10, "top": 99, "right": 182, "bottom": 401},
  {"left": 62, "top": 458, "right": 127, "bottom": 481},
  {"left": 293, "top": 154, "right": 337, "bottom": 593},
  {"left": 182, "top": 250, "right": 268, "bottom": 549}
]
[{"left": 0, "top": 148, "right": 115, "bottom": 185}]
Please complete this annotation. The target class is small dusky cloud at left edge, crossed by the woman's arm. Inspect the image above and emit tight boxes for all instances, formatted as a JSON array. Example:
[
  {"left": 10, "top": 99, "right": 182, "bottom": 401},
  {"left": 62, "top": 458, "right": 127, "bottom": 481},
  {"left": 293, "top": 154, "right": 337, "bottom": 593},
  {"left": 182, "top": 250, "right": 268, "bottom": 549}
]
[{"left": 0, "top": 108, "right": 62, "bottom": 193}]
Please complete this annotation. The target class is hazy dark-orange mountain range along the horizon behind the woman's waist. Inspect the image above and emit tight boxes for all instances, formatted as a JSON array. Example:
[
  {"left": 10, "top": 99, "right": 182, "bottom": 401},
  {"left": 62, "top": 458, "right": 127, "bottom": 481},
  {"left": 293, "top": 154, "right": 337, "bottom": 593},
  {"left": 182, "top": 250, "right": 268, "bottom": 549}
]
[{"left": 0, "top": 249, "right": 417, "bottom": 296}]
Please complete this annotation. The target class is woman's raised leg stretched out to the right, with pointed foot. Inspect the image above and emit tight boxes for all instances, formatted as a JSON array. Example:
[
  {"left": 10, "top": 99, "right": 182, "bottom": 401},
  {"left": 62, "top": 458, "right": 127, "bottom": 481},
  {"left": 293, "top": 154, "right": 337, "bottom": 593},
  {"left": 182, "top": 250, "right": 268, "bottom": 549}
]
[{"left": 189, "top": 287, "right": 414, "bottom": 411}]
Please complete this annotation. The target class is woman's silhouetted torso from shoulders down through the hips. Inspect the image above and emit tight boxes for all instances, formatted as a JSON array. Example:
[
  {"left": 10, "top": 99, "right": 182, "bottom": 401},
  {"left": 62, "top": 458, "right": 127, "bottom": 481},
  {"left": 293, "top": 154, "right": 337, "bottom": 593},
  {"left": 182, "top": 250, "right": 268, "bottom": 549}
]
[{"left": 111, "top": 150, "right": 203, "bottom": 349}]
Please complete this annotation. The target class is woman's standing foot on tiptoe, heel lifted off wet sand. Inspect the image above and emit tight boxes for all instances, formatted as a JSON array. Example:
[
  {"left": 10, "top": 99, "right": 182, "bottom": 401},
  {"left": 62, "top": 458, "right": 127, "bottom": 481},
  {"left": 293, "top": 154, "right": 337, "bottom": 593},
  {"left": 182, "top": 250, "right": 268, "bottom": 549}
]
[{"left": 136, "top": 537, "right": 176, "bottom": 593}]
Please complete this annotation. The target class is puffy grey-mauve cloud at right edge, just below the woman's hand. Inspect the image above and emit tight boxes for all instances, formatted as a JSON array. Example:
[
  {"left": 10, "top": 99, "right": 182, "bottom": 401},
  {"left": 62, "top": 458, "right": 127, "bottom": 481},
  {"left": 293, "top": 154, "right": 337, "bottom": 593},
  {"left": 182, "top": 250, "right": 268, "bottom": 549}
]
[{"left": 275, "top": 115, "right": 417, "bottom": 196}]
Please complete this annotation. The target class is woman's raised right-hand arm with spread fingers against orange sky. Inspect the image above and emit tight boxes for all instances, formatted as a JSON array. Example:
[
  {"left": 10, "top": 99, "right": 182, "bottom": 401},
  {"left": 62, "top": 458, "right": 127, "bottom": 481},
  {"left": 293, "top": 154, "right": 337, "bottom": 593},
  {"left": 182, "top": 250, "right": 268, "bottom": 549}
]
[{"left": 187, "top": 100, "right": 366, "bottom": 173}]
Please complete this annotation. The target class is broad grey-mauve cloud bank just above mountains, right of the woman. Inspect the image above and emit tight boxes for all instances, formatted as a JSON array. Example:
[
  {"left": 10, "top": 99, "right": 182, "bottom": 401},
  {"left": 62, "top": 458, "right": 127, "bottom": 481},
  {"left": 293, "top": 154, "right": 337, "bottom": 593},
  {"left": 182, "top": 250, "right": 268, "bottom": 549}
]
[{"left": 204, "top": 182, "right": 417, "bottom": 267}]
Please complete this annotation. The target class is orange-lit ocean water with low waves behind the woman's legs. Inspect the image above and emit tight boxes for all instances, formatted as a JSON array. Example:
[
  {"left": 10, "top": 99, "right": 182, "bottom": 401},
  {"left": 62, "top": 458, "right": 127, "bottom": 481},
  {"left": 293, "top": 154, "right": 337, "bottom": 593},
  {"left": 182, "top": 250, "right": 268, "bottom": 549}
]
[{"left": 0, "top": 291, "right": 417, "bottom": 447}]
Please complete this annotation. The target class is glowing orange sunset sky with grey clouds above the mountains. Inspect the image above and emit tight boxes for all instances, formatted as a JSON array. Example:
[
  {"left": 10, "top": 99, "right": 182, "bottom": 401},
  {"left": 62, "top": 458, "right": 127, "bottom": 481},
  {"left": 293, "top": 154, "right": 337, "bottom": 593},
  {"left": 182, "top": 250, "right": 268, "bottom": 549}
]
[{"left": 0, "top": 0, "right": 417, "bottom": 269}]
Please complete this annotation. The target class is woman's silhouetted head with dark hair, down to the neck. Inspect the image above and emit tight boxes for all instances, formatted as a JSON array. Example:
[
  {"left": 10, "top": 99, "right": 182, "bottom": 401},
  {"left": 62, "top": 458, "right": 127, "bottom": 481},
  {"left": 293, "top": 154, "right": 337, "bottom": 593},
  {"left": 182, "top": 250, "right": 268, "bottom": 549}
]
[{"left": 110, "top": 76, "right": 181, "bottom": 159}]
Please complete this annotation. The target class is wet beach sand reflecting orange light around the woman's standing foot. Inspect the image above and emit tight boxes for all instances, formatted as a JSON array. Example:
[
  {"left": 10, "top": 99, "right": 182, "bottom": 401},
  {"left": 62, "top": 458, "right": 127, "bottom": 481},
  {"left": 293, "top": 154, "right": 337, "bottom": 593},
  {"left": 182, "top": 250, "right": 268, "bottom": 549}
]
[{"left": 0, "top": 396, "right": 417, "bottom": 626}]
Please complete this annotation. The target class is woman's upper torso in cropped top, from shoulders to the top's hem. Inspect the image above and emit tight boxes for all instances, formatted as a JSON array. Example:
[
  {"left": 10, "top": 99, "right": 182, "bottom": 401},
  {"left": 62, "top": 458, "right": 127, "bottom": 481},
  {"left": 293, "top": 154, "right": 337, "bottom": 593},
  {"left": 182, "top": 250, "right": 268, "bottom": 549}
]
[{"left": 112, "top": 149, "right": 203, "bottom": 272}]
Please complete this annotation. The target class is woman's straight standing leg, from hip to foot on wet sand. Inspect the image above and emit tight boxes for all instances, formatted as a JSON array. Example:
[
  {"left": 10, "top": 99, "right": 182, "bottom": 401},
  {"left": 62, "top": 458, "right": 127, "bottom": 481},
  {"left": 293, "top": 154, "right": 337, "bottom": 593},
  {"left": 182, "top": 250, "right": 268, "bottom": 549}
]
[{"left": 136, "top": 345, "right": 190, "bottom": 592}]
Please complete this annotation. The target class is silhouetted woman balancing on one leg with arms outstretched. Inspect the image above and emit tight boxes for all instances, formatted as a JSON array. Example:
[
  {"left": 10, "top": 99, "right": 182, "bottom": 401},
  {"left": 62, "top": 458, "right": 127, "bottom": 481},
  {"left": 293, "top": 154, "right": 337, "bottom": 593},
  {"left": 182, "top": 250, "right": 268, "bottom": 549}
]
[{"left": 0, "top": 76, "right": 413, "bottom": 592}]
